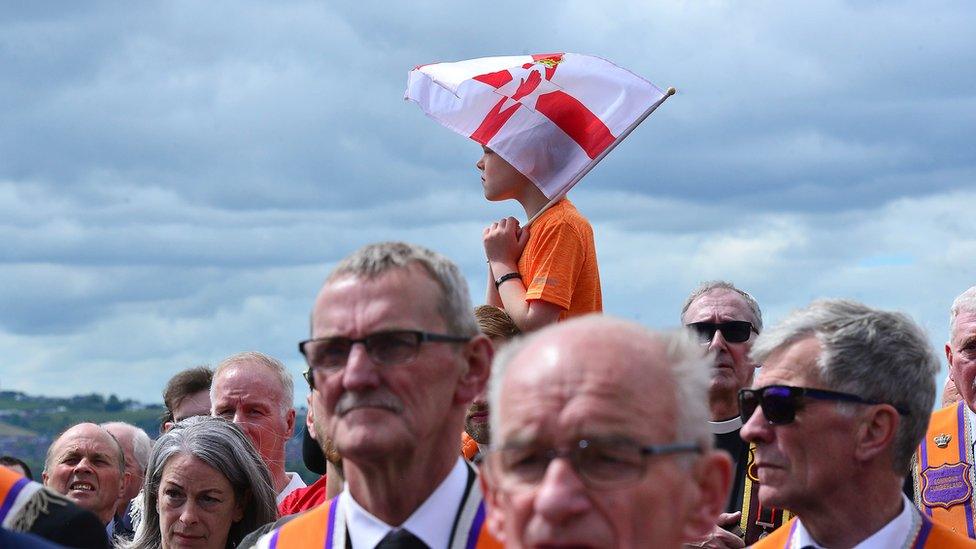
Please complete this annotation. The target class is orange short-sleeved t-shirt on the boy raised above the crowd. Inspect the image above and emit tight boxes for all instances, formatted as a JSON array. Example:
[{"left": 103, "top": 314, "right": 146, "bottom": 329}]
[{"left": 518, "top": 199, "right": 603, "bottom": 320}]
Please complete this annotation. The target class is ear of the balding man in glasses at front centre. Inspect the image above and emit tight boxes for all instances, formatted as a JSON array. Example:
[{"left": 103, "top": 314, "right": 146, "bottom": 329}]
[{"left": 684, "top": 450, "right": 732, "bottom": 540}]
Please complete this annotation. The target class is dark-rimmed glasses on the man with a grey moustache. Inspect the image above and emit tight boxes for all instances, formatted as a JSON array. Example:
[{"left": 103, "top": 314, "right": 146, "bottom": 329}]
[{"left": 298, "top": 330, "right": 471, "bottom": 389}]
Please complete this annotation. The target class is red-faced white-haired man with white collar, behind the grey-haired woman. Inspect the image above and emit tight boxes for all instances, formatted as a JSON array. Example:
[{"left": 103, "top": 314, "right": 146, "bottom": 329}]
[{"left": 210, "top": 351, "right": 305, "bottom": 503}]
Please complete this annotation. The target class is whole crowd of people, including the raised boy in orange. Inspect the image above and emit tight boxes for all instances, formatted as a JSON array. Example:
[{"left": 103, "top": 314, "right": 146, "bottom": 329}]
[{"left": 0, "top": 148, "right": 976, "bottom": 549}]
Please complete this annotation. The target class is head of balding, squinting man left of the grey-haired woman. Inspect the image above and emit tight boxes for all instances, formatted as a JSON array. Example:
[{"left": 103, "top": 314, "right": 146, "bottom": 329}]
[{"left": 41, "top": 423, "right": 129, "bottom": 535}]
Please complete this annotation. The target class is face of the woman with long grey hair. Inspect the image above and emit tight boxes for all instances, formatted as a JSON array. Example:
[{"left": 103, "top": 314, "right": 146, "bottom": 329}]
[{"left": 156, "top": 454, "right": 244, "bottom": 549}]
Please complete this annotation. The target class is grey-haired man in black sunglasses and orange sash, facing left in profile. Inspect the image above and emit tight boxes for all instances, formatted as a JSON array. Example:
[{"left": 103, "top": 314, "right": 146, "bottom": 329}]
[{"left": 739, "top": 300, "right": 976, "bottom": 549}]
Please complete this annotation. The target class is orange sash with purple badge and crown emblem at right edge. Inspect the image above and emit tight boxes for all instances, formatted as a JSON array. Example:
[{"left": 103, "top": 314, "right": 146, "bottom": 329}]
[{"left": 912, "top": 402, "right": 976, "bottom": 538}]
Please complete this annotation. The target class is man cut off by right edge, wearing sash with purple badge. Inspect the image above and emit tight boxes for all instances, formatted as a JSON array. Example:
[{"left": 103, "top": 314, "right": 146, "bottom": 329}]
[{"left": 913, "top": 286, "right": 976, "bottom": 538}]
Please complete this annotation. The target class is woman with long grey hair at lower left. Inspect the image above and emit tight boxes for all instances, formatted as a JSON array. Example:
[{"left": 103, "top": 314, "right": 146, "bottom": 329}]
[{"left": 119, "top": 416, "right": 277, "bottom": 549}]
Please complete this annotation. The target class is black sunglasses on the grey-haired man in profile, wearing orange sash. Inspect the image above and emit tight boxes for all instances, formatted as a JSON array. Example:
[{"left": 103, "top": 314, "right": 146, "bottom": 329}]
[{"left": 739, "top": 385, "right": 909, "bottom": 425}]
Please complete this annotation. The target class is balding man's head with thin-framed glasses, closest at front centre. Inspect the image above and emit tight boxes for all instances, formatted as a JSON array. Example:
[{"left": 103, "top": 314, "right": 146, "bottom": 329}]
[{"left": 482, "top": 316, "right": 731, "bottom": 549}]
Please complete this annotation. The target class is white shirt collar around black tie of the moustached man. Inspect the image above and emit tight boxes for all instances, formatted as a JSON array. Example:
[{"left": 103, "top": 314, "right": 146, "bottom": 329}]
[{"left": 338, "top": 458, "right": 468, "bottom": 548}]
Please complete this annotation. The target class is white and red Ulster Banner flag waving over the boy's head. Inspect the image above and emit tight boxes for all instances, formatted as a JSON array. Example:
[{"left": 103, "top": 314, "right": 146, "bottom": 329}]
[{"left": 404, "top": 53, "right": 674, "bottom": 199}]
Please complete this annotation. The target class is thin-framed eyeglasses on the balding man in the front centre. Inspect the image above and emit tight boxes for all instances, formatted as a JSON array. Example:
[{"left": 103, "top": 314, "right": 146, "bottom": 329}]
[{"left": 487, "top": 438, "right": 702, "bottom": 491}]
